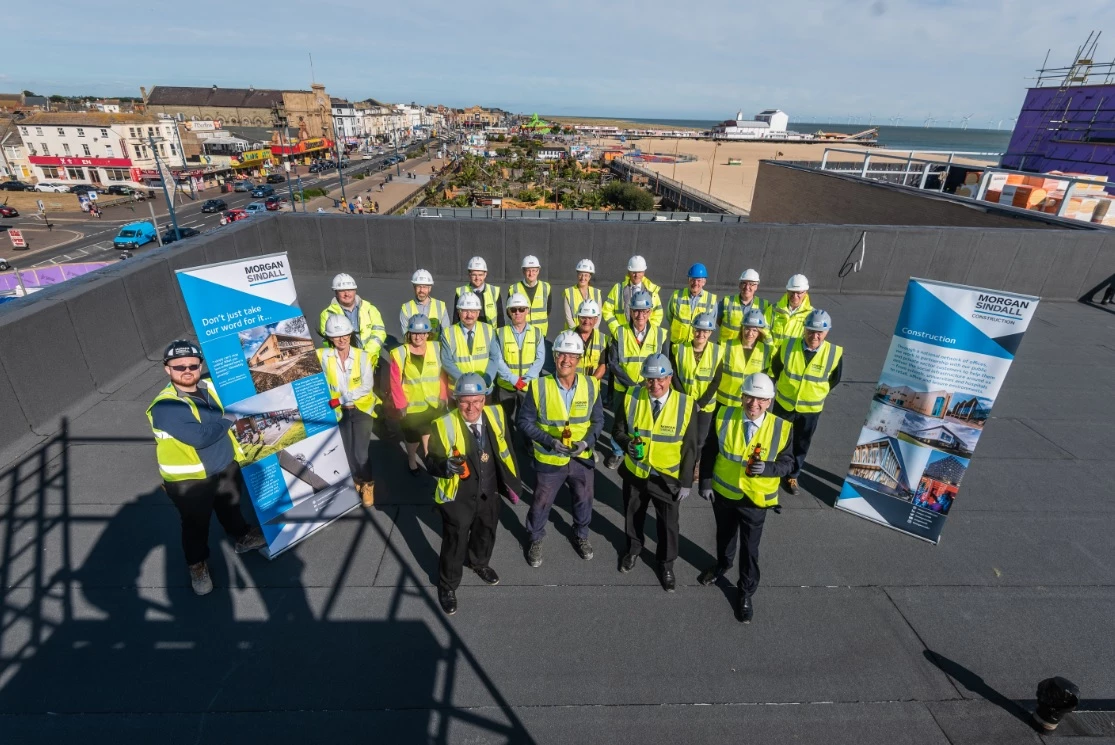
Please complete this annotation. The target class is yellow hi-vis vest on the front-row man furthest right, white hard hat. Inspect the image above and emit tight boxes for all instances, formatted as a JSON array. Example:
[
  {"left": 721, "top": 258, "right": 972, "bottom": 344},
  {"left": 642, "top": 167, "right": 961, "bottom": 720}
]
[{"left": 712, "top": 406, "right": 793, "bottom": 507}]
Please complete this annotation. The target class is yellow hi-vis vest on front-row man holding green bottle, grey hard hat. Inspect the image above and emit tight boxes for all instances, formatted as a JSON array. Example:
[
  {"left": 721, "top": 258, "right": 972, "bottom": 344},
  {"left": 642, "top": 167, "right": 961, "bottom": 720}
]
[{"left": 621, "top": 386, "right": 694, "bottom": 481}]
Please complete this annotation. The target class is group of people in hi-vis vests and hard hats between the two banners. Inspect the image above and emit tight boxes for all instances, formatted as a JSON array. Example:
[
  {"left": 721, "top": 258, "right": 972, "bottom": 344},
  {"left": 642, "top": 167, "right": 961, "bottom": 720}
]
[{"left": 153, "top": 255, "right": 843, "bottom": 622}]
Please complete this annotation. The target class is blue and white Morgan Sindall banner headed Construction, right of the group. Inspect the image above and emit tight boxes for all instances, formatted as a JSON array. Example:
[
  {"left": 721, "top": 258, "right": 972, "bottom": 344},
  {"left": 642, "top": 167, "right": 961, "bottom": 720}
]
[{"left": 836, "top": 279, "right": 1038, "bottom": 543}]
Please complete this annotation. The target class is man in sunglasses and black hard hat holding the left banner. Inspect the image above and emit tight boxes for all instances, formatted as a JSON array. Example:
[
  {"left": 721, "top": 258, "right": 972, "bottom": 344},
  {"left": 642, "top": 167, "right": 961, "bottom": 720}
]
[{"left": 147, "top": 339, "right": 266, "bottom": 594}]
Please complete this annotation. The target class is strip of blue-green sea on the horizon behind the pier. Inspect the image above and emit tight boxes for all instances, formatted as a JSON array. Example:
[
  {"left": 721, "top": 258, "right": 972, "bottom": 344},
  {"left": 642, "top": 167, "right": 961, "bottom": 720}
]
[{"left": 624, "top": 117, "right": 1010, "bottom": 155}]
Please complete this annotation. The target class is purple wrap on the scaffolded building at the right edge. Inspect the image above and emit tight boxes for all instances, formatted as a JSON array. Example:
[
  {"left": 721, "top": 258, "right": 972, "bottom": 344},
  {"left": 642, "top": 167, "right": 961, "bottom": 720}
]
[{"left": 1001, "top": 85, "right": 1115, "bottom": 181}]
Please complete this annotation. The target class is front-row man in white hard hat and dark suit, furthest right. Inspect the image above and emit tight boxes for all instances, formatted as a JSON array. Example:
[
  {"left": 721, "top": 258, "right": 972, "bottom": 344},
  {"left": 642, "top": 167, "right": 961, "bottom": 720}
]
[{"left": 697, "top": 373, "right": 794, "bottom": 623}]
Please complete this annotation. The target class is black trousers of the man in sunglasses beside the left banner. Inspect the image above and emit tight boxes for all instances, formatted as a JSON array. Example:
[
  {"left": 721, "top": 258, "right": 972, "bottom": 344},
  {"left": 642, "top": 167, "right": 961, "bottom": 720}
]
[{"left": 163, "top": 463, "right": 249, "bottom": 564}]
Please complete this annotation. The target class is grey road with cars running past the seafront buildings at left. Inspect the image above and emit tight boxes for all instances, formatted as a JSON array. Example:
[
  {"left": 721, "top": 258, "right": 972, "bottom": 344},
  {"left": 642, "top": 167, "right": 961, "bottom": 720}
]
[{"left": 0, "top": 143, "right": 443, "bottom": 269}]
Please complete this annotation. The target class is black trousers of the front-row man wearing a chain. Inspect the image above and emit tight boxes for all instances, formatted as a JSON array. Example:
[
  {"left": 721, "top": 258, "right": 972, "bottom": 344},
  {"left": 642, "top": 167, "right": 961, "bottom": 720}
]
[{"left": 438, "top": 494, "right": 502, "bottom": 590}]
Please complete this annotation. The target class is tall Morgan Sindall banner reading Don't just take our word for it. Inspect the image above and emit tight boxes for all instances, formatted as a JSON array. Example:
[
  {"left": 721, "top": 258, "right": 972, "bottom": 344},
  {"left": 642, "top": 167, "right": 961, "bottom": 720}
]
[{"left": 177, "top": 253, "right": 360, "bottom": 558}]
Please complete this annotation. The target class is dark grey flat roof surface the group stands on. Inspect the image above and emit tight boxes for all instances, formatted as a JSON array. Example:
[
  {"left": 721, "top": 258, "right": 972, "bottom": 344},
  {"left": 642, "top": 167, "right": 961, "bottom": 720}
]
[{"left": 0, "top": 272, "right": 1115, "bottom": 745}]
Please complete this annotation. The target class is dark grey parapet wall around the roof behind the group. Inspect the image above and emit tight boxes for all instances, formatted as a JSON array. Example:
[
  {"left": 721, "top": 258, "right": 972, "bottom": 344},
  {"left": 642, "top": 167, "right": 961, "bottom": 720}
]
[{"left": 0, "top": 214, "right": 1115, "bottom": 456}]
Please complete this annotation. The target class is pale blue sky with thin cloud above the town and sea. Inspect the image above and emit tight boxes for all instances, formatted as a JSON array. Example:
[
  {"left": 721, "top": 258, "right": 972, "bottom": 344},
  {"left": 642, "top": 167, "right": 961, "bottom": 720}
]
[{"left": 0, "top": 0, "right": 1115, "bottom": 125}]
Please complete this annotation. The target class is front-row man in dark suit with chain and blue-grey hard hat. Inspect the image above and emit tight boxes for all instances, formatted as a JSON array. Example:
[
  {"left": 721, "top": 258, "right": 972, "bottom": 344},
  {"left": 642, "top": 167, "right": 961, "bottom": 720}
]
[{"left": 426, "top": 373, "right": 523, "bottom": 616}]
